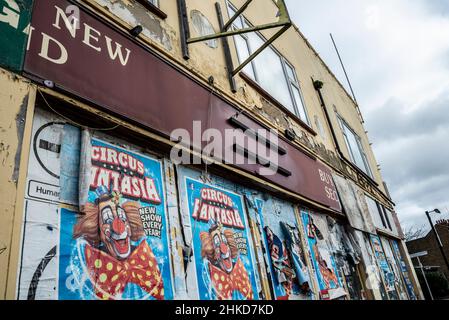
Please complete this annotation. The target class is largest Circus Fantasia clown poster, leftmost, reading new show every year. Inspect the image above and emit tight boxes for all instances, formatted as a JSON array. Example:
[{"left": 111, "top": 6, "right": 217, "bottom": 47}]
[{"left": 59, "top": 139, "right": 173, "bottom": 300}]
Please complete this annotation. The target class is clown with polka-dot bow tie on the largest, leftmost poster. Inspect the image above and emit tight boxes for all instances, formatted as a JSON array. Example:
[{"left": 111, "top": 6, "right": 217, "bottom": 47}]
[{"left": 74, "top": 186, "right": 164, "bottom": 300}]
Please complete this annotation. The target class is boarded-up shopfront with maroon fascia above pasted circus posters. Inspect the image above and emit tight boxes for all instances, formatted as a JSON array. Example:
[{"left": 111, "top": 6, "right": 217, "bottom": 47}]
[{"left": 7, "top": 0, "right": 420, "bottom": 300}]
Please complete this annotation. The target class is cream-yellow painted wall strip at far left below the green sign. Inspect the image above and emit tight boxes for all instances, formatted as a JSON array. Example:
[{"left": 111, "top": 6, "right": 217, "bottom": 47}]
[{"left": 0, "top": 69, "right": 30, "bottom": 298}]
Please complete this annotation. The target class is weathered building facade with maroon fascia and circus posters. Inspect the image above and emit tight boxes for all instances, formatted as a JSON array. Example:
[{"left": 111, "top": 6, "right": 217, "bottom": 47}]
[{"left": 0, "top": 0, "right": 422, "bottom": 300}]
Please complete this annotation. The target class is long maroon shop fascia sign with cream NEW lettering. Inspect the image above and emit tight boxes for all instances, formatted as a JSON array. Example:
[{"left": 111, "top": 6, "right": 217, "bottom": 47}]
[{"left": 25, "top": 0, "right": 341, "bottom": 212}]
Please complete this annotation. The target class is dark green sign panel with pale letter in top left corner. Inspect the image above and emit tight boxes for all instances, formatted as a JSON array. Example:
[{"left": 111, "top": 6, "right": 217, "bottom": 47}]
[{"left": 0, "top": 0, "right": 33, "bottom": 71}]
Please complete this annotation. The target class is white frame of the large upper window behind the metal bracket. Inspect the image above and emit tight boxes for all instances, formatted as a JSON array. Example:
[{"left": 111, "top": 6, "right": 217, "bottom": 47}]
[{"left": 226, "top": 0, "right": 313, "bottom": 126}]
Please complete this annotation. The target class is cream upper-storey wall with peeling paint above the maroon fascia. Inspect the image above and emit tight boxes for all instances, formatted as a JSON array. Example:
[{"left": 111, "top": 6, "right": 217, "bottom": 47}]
[{"left": 77, "top": 0, "right": 388, "bottom": 208}]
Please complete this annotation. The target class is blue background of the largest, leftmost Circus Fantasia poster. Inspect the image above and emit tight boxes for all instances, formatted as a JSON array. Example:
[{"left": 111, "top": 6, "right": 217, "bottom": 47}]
[{"left": 59, "top": 139, "right": 174, "bottom": 300}]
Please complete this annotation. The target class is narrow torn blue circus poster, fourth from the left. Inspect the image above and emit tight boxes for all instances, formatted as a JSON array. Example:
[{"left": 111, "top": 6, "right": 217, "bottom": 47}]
[{"left": 301, "top": 211, "right": 346, "bottom": 300}]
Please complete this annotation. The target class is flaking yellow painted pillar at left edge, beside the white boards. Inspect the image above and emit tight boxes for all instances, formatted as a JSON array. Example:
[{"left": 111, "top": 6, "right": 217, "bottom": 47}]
[{"left": 0, "top": 69, "right": 35, "bottom": 299}]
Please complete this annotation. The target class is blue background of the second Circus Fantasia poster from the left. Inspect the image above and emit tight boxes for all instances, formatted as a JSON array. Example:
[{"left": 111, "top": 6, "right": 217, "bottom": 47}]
[{"left": 185, "top": 177, "right": 259, "bottom": 300}]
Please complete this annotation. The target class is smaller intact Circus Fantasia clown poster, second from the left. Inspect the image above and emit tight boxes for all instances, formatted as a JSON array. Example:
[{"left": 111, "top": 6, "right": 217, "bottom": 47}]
[{"left": 185, "top": 177, "right": 259, "bottom": 300}]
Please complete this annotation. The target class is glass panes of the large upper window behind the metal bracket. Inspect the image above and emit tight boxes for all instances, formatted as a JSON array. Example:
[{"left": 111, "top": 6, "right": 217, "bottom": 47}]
[{"left": 228, "top": 2, "right": 310, "bottom": 126}]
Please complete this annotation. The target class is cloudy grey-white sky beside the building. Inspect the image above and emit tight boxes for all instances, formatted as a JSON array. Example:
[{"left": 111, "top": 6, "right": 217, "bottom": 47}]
[{"left": 287, "top": 0, "right": 449, "bottom": 228}]
